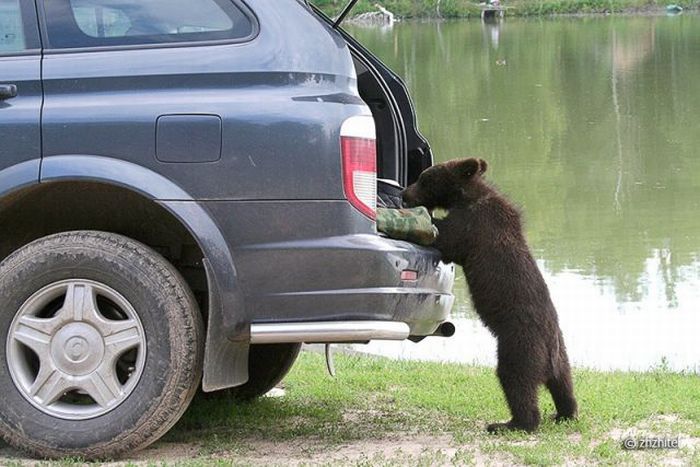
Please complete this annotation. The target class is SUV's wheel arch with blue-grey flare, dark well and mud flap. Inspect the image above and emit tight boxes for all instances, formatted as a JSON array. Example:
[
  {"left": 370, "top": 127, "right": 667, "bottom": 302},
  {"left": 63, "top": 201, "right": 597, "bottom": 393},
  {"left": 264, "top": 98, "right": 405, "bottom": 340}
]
[{"left": 0, "top": 155, "right": 249, "bottom": 391}]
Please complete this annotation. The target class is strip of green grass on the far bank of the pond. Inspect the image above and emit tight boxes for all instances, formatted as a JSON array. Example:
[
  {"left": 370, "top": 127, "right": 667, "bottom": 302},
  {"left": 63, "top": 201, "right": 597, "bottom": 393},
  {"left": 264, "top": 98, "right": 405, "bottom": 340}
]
[{"left": 312, "top": 0, "right": 700, "bottom": 18}]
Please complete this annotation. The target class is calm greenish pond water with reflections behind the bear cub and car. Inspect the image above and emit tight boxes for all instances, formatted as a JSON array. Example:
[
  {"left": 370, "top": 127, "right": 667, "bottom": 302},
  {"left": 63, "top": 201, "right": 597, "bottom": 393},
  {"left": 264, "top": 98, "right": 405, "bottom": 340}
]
[{"left": 349, "top": 15, "right": 700, "bottom": 371}]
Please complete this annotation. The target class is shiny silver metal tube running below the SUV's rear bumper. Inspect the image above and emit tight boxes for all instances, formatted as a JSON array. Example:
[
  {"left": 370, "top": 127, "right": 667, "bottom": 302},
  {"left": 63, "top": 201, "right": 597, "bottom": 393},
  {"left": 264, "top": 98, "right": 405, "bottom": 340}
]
[{"left": 250, "top": 321, "right": 410, "bottom": 344}]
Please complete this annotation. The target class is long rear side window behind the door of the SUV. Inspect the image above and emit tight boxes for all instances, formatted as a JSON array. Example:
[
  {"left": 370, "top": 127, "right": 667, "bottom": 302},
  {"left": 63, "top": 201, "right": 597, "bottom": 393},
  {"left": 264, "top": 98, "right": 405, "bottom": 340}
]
[{"left": 41, "top": 0, "right": 254, "bottom": 49}]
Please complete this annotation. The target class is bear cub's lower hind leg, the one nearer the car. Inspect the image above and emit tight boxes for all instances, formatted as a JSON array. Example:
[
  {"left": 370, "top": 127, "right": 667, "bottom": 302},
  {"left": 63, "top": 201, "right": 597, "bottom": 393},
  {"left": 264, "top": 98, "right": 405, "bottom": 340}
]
[{"left": 487, "top": 363, "right": 540, "bottom": 433}]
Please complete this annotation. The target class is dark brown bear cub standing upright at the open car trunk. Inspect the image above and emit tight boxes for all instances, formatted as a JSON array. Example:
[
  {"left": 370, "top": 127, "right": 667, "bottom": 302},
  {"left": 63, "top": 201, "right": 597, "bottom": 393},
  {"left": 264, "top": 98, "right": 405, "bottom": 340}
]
[{"left": 403, "top": 159, "right": 577, "bottom": 432}]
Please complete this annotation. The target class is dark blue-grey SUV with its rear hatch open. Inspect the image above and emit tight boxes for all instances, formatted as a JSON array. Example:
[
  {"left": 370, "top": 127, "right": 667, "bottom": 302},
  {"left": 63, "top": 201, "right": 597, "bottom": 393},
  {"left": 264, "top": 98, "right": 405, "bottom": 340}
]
[{"left": 0, "top": 0, "right": 454, "bottom": 459}]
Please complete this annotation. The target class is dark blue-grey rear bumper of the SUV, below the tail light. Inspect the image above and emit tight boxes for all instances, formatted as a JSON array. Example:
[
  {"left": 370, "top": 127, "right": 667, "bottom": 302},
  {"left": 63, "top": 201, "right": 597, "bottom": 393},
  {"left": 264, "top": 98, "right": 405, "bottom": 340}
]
[{"left": 236, "top": 234, "right": 454, "bottom": 336}]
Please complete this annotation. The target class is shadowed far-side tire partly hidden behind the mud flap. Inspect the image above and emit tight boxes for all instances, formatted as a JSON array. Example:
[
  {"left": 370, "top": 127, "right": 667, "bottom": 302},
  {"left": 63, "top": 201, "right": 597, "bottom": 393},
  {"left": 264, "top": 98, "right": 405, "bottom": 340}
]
[{"left": 202, "top": 344, "right": 301, "bottom": 401}]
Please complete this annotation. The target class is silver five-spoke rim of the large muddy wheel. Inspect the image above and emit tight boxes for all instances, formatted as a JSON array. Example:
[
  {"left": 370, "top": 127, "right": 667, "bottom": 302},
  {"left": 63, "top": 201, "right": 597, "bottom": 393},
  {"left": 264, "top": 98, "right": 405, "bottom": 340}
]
[{"left": 7, "top": 280, "right": 146, "bottom": 420}]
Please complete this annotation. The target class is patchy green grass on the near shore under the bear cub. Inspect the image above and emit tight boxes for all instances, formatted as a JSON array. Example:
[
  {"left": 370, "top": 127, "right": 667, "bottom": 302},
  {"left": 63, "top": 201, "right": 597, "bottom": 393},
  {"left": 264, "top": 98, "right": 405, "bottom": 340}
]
[{"left": 152, "top": 353, "right": 700, "bottom": 465}]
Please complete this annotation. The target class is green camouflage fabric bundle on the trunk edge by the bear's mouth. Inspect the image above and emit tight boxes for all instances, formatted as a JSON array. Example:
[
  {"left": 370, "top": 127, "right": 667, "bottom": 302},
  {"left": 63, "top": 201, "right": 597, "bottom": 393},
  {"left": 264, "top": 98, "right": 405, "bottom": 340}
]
[{"left": 377, "top": 206, "right": 438, "bottom": 245}]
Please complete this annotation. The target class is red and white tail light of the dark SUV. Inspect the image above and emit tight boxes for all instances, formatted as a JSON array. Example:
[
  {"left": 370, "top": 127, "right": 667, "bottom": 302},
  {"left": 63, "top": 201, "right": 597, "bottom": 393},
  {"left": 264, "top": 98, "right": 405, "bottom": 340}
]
[{"left": 340, "top": 115, "right": 377, "bottom": 219}]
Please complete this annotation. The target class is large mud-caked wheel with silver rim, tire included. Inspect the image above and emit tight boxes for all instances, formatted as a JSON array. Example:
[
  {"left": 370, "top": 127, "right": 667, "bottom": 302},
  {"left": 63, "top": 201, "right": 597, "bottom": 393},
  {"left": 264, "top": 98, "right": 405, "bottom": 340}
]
[{"left": 0, "top": 231, "right": 203, "bottom": 459}]
